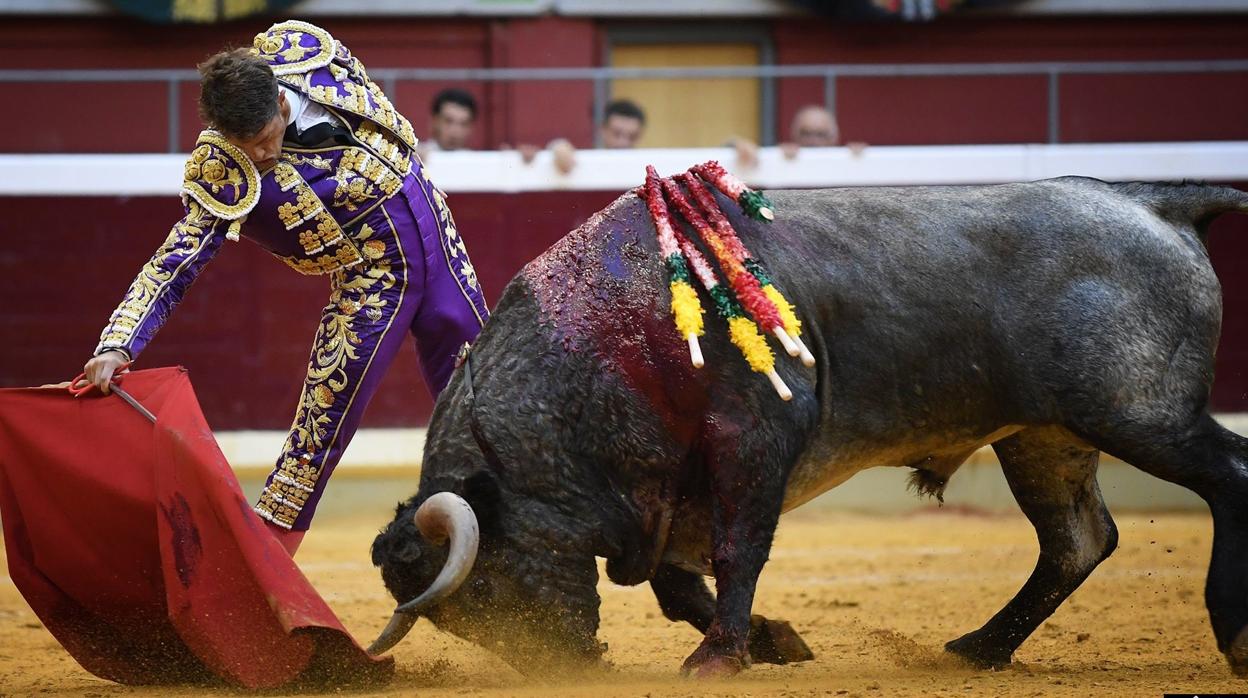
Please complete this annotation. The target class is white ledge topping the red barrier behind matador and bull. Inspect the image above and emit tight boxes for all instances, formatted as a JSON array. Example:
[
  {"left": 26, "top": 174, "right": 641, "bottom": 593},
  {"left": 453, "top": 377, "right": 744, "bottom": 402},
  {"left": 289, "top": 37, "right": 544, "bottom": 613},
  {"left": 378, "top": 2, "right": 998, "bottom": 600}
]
[{"left": 0, "top": 141, "right": 1248, "bottom": 196}]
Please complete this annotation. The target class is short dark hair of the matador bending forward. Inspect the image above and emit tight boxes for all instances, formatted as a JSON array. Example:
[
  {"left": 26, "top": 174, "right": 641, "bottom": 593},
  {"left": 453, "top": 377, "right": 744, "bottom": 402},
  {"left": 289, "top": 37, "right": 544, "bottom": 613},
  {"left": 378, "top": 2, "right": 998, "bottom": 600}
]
[{"left": 198, "top": 49, "right": 277, "bottom": 139}]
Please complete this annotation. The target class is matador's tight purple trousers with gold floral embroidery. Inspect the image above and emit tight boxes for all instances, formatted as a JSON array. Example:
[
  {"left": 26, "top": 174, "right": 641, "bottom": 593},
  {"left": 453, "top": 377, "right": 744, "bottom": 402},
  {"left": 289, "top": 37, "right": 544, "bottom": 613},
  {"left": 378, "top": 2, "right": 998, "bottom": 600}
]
[{"left": 256, "top": 167, "right": 489, "bottom": 531}]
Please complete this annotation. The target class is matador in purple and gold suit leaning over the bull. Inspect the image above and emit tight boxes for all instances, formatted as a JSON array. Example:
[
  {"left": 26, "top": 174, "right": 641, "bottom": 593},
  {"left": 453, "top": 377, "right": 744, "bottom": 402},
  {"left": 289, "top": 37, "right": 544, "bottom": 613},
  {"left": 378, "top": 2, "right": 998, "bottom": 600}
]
[{"left": 86, "top": 21, "right": 488, "bottom": 553}]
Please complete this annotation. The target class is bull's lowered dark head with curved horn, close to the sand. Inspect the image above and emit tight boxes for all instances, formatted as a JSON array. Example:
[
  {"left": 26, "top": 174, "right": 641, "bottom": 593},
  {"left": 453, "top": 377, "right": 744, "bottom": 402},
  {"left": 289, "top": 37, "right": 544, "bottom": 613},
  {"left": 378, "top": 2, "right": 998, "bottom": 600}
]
[{"left": 369, "top": 472, "right": 603, "bottom": 673}]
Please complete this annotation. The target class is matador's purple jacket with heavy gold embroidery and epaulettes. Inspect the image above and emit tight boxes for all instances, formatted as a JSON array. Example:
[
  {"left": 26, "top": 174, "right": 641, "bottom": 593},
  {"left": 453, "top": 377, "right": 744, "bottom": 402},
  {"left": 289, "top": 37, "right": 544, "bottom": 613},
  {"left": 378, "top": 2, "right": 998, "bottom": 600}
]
[{"left": 95, "top": 21, "right": 426, "bottom": 358}]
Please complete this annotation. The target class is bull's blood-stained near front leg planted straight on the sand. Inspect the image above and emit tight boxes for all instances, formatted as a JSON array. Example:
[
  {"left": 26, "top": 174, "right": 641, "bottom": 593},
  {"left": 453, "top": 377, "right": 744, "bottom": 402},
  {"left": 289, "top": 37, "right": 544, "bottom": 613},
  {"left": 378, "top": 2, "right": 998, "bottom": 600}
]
[{"left": 681, "top": 428, "right": 796, "bottom": 677}]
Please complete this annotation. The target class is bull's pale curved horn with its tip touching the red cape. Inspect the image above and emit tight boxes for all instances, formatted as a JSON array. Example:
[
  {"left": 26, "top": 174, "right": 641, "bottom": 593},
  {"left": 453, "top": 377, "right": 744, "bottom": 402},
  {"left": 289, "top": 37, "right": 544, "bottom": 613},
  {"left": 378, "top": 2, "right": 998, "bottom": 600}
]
[{"left": 368, "top": 492, "right": 480, "bottom": 654}]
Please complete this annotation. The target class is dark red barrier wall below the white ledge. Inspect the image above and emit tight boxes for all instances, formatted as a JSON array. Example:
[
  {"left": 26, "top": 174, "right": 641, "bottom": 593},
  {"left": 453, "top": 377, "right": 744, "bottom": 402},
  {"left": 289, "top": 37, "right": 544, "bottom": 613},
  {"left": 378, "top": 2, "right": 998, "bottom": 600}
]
[{"left": 0, "top": 182, "right": 1248, "bottom": 430}]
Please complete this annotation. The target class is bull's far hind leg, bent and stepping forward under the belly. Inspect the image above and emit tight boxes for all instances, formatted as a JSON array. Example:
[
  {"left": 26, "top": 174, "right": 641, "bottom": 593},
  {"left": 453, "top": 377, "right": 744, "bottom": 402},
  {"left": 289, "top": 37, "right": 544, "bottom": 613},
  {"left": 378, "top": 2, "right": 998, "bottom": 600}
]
[{"left": 945, "top": 427, "right": 1118, "bottom": 667}]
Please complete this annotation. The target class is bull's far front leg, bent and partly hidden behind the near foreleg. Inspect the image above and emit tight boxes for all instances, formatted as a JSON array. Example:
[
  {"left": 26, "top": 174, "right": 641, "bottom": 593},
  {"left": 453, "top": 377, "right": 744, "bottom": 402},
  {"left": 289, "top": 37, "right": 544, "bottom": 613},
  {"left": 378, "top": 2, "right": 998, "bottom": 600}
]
[{"left": 650, "top": 564, "right": 815, "bottom": 664}]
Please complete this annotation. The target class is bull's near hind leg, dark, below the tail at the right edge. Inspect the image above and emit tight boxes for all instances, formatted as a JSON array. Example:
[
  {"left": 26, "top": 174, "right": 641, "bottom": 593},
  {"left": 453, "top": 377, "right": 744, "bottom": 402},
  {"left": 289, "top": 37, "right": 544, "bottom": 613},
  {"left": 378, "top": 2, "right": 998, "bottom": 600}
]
[{"left": 1103, "top": 413, "right": 1248, "bottom": 677}]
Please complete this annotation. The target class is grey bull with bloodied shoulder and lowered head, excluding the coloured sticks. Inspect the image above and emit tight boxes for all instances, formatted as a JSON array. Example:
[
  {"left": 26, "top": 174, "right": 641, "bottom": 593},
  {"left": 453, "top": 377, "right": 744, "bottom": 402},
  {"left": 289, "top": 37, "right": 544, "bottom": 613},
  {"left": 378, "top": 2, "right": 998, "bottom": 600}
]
[{"left": 373, "top": 177, "right": 1248, "bottom": 674}]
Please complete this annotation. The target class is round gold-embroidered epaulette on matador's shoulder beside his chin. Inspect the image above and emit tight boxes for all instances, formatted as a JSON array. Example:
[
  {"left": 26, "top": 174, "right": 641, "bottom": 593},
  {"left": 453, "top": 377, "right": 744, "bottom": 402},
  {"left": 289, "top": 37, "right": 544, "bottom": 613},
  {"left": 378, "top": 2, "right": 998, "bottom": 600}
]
[{"left": 182, "top": 130, "right": 260, "bottom": 240}]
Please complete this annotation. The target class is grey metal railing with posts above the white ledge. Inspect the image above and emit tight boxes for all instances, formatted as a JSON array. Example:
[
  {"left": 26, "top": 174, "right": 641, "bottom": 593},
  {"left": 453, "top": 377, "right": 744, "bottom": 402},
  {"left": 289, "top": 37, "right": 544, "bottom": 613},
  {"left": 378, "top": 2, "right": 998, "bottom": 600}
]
[{"left": 0, "top": 60, "right": 1248, "bottom": 152}]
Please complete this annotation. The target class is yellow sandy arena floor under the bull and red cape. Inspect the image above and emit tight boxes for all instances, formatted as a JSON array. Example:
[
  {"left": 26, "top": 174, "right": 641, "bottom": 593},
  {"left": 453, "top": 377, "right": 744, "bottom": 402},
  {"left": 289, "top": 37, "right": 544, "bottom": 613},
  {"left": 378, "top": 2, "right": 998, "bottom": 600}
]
[{"left": 0, "top": 508, "right": 1248, "bottom": 698}]
